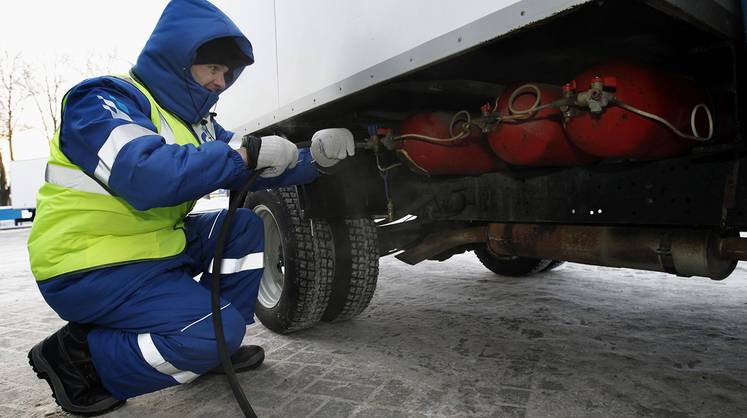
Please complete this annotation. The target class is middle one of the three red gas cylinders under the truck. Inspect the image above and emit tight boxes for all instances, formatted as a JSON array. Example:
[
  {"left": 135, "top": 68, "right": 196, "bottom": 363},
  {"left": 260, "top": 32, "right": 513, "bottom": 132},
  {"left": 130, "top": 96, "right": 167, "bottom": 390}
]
[{"left": 488, "top": 83, "right": 597, "bottom": 167}]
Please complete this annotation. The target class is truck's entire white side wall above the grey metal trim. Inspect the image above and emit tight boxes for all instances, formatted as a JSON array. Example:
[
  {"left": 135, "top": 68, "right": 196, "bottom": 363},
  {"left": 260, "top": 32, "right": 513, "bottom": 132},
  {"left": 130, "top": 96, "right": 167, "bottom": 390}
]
[{"left": 214, "top": 0, "right": 519, "bottom": 128}]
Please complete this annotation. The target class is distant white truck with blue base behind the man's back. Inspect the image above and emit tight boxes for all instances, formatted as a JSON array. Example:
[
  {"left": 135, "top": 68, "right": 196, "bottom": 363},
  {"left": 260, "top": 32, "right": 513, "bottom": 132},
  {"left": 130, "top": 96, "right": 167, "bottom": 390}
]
[{"left": 0, "top": 158, "right": 47, "bottom": 225}]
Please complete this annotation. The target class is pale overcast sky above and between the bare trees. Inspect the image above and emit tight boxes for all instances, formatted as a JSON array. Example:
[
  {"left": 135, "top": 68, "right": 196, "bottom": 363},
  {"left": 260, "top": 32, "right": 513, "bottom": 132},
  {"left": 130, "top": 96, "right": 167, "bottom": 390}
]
[{"left": 0, "top": 0, "right": 168, "bottom": 159}]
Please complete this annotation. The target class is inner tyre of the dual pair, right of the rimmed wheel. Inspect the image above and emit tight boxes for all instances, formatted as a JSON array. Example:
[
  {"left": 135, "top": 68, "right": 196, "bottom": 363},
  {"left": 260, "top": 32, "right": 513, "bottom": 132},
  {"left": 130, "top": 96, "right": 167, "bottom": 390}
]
[{"left": 322, "top": 219, "right": 379, "bottom": 322}]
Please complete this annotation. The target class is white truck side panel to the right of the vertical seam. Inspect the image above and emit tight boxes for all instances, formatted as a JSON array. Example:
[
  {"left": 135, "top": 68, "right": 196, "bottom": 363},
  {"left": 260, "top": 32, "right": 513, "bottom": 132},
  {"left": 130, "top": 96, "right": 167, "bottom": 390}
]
[{"left": 276, "top": 0, "right": 518, "bottom": 106}]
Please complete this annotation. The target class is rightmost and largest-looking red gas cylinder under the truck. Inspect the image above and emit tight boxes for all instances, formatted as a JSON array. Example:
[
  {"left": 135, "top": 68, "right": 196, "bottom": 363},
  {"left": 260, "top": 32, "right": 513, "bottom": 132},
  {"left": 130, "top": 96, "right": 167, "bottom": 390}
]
[{"left": 566, "top": 62, "right": 709, "bottom": 159}]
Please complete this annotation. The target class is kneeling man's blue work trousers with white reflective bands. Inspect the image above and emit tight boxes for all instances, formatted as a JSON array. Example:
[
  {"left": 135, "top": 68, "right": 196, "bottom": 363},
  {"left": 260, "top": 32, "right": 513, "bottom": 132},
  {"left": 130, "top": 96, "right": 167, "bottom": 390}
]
[{"left": 39, "top": 209, "right": 264, "bottom": 399}]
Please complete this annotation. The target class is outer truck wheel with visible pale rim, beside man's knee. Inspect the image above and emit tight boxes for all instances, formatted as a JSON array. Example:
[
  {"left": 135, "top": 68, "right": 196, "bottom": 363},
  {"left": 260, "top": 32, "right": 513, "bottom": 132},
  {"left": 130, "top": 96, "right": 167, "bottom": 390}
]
[{"left": 244, "top": 188, "right": 334, "bottom": 333}]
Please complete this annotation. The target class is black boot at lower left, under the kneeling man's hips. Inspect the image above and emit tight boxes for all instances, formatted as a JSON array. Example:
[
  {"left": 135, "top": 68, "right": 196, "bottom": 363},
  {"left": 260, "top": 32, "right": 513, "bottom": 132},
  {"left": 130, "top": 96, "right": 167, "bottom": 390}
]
[{"left": 28, "top": 323, "right": 125, "bottom": 415}]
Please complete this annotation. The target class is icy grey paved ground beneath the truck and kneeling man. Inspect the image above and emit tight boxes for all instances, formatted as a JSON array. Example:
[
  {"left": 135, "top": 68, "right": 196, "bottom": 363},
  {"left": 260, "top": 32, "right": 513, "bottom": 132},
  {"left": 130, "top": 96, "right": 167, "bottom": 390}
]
[{"left": 0, "top": 229, "right": 747, "bottom": 418}]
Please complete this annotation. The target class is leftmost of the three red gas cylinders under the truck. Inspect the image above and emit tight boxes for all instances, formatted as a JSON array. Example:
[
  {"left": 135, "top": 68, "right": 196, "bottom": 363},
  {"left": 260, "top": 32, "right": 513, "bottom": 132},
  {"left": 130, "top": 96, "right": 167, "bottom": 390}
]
[{"left": 397, "top": 112, "right": 502, "bottom": 175}]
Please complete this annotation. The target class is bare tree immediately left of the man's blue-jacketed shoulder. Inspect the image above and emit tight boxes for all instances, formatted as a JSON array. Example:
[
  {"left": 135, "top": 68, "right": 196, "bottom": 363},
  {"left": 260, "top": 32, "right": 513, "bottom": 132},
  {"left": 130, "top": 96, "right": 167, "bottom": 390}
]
[{"left": 23, "top": 55, "right": 70, "bottom": 140}]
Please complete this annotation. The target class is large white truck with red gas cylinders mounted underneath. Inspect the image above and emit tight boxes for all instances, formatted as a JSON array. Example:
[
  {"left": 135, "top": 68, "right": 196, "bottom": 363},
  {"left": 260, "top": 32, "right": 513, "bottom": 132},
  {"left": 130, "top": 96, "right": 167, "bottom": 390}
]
[{"left": 216, "top": 0, "right": 747, "bottom": 333}]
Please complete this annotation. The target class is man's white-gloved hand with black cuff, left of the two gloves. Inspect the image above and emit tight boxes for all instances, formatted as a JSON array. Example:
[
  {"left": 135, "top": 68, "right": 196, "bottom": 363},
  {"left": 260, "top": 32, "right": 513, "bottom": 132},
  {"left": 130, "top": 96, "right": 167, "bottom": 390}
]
[{"left": 241, "top": 135, "right": 298, "bottom": 177}]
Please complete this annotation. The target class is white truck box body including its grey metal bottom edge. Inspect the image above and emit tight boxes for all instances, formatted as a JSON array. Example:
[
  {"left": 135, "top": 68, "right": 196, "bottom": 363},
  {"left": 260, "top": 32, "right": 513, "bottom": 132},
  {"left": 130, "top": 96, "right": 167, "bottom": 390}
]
[{"left": 215, "top": 0, "right": 739, "bottom": 134}]
